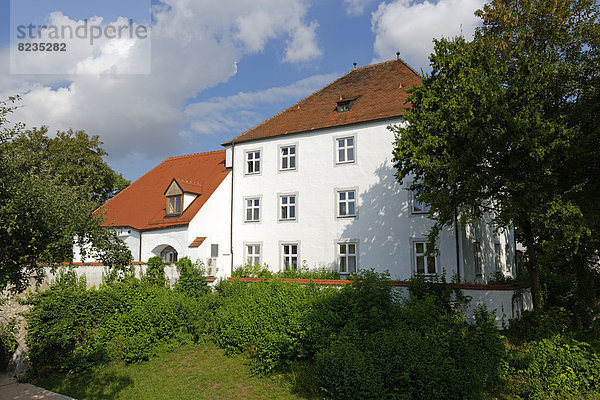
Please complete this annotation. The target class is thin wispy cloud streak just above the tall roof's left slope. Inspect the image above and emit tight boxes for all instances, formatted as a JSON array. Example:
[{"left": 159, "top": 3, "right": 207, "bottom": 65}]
[{"left": 185, "top": 74, "right": 339, "bottom": 138}]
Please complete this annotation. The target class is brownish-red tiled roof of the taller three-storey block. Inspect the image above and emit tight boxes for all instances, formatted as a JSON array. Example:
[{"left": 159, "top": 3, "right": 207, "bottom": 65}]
[{"left": 223, "top": 59, "right": 421, "bottom": 146}]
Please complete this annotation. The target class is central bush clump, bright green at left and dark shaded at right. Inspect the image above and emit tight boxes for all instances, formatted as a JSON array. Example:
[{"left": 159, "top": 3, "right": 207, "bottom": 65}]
[{"left": 213, "top": 271, "right": 504, "bottom": 399}]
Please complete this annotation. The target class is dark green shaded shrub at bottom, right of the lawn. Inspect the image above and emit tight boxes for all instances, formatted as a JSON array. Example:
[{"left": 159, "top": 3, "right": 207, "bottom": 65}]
[{"left": 316, "top": 297, "right": 504, "bottom": 399}]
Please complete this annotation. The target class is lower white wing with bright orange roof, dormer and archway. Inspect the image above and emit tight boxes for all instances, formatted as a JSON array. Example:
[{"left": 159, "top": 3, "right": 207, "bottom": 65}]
[{"left": 75, "top": 150, "right": 231, "bottom": 277}]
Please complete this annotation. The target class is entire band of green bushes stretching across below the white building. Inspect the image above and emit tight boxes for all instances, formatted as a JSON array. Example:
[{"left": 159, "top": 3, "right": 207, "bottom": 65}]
[{"left": 27, "top": 268, "right": 600, "bottom": 399}]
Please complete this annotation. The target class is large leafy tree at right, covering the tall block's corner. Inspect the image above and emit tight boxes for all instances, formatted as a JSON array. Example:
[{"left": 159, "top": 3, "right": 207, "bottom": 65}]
[{"left": 392, "top": 0, "right": 600, "bottom": 309}]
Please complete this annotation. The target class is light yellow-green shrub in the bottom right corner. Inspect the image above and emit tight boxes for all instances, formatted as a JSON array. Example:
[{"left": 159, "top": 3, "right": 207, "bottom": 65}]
[{"left": 509, "top": 335, "right": 600, "bottom": 399}]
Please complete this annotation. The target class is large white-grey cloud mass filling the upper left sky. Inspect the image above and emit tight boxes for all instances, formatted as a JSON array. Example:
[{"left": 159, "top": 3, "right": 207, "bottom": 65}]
[{"left": 0, "top": 0, "right": 320, "bottom": 172}]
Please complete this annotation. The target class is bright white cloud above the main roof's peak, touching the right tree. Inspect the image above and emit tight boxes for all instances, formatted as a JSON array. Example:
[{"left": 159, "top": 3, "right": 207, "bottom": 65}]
[{"left": 372, "top": 0, "right": 485, "bottom": 70}]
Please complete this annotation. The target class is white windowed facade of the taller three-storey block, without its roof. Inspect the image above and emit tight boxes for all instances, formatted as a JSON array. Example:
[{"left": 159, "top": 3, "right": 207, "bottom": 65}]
[{"left": 227, "top": 119, "right": 514, "bottom": 283}]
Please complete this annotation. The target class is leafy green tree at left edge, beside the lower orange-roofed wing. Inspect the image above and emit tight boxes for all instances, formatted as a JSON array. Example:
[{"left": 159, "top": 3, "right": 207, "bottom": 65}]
[{"left": 0, "top": 98, "right": 131, "bottom": 291}]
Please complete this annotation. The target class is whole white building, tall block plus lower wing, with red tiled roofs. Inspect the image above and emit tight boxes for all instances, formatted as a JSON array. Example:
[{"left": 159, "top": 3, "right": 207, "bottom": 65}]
[{"left": 83, "top": 60, "right": 515, "bottom": 283}]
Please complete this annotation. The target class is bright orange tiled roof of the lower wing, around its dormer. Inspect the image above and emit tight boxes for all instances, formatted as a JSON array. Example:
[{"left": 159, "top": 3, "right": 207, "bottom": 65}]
[{"left": 101, "top": 150, "right": 229, "bottom": 230}]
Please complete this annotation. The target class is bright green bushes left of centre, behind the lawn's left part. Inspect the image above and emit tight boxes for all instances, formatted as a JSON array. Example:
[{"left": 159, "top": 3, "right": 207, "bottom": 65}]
[{"left": 27, "top": 272, "right": 206, "bottom": 374}]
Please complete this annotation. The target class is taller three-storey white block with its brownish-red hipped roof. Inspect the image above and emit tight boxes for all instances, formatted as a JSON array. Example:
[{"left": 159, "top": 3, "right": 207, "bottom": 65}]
[{"left": 224, "top": 60, "right": 514, "bottom": 282}]
